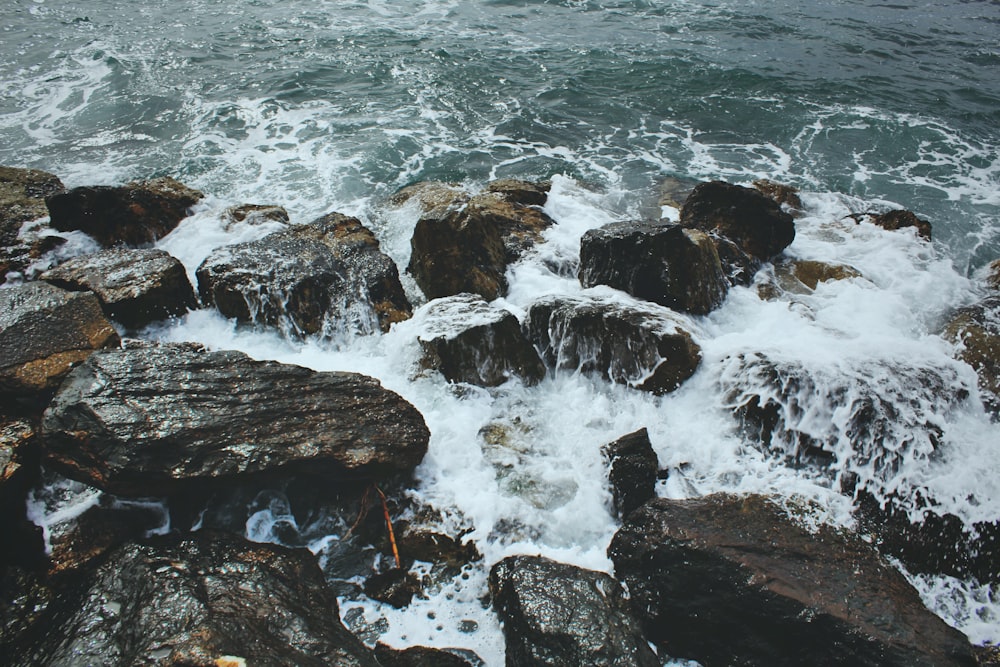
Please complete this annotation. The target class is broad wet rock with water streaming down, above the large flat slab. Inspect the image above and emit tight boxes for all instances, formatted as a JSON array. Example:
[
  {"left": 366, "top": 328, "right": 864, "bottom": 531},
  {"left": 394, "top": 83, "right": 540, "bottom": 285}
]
[{"left": 197, "top": 213, "right": 411, "bottom": 336}]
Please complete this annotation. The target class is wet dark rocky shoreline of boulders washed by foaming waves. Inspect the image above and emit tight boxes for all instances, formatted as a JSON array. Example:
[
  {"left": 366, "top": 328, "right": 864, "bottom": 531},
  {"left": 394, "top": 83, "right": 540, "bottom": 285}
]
[{"left": 0, "top": 167, "right": 1000, "bottom": 667}]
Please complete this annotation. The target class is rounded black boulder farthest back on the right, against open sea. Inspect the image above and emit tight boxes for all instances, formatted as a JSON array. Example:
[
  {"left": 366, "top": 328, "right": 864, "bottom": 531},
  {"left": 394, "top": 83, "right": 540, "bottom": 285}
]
[{"left": 680, "top": 181, "right": 795, "bottom": 262}]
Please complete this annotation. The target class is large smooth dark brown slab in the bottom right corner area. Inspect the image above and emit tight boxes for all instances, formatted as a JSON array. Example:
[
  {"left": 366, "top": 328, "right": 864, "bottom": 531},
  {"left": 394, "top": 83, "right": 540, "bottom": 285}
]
[{"left": 608, "top": 495, "right": 975, "bottom": 667}]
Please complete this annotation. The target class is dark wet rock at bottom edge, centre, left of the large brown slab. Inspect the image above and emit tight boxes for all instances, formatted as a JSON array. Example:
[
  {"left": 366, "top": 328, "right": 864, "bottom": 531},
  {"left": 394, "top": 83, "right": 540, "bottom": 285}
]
[{"left": 490, "top": 556, "right": 660, "bottom": 667}]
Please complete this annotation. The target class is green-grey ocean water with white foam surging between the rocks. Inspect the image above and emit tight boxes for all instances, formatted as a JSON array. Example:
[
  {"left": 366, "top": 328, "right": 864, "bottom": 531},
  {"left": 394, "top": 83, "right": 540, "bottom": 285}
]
[{"left": 0, "top": 0, "right": 1000, "bottom": 665}]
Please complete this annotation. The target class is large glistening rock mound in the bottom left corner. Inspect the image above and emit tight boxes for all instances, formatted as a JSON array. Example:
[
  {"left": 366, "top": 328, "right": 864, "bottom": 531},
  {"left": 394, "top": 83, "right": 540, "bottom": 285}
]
[{"left": 2, "top": 533, "right": 378, "bottom": 667}]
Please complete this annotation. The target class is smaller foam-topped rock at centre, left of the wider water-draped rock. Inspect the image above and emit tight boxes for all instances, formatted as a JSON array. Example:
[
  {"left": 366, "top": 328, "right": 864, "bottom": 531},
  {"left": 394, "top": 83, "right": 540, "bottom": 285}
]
[{"left": 416, "top": 294, "right": 545, "bottom": 387}]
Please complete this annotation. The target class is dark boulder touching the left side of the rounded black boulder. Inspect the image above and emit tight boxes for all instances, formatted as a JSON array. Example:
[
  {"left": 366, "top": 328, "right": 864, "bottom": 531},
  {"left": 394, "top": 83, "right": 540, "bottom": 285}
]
[{"left": 580, "top": 222, "right": 728, "bottom": 315}]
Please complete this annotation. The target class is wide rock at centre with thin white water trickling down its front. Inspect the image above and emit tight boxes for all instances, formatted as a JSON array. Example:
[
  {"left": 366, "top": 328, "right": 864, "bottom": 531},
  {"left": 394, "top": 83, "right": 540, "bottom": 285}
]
[{"left": 526, "top": 296, "right": 701, "bottom": 394}]
